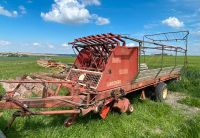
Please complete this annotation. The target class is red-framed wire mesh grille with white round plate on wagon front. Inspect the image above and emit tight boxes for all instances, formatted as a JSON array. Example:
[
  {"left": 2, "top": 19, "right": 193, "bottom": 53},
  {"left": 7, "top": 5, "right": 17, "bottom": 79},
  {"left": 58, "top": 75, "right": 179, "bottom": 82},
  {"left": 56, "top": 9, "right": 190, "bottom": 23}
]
[{"left": 67, "top": 69, "right": 101, "bottom": 88}]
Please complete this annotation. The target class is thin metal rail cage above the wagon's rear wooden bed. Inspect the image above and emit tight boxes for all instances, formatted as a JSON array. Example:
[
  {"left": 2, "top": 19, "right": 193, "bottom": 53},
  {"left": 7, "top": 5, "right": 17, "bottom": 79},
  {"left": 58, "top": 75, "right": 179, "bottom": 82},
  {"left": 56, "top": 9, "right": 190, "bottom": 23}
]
[{"left": 122, "top": 31, "right": 189, "bottom": 72}]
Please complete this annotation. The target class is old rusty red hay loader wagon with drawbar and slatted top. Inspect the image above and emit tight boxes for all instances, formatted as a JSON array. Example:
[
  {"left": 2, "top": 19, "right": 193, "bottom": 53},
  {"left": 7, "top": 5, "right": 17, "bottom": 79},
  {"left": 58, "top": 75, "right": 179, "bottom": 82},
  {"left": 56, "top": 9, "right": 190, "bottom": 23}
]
[{"left": 0, "top": 32, "right": 188, "bottom": 128}]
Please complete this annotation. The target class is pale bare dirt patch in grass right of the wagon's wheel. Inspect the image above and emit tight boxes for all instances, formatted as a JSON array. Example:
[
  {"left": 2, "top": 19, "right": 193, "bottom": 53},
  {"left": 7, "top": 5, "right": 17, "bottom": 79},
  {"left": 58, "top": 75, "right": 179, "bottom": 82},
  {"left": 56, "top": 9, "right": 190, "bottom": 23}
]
[{"left": 165, "top": 92, "right": 200, "bottom": 116}]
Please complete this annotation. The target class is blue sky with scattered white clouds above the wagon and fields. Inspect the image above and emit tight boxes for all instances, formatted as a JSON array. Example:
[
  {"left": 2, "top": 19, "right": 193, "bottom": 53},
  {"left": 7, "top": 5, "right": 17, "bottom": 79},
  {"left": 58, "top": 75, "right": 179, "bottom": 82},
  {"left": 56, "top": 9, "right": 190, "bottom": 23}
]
[{"left": 0, "top": 0, "right": 200, "bottom": 55}]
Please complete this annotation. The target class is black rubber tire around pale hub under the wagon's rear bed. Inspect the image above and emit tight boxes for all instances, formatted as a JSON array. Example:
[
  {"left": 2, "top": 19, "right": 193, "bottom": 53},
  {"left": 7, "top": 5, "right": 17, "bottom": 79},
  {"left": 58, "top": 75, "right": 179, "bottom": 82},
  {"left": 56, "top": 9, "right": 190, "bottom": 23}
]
[{"left": 155, "top": 82, "right": 167, "bottom": 102}]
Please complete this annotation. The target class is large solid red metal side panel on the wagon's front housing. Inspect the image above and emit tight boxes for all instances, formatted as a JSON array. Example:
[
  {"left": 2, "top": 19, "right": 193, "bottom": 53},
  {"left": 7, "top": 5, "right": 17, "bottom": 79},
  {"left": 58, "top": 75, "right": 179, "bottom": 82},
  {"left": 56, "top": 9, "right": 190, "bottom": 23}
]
[{"left": 97, "top": 47, "right": 138, "bottom": 92}]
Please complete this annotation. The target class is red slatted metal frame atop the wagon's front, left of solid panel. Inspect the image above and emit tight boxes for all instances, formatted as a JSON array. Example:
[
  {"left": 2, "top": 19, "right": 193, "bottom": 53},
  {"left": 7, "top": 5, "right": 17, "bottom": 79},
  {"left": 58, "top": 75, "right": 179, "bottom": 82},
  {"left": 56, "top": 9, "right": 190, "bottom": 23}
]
[{"left": 69, "top": 33, "right": 126, "bottom": 71}]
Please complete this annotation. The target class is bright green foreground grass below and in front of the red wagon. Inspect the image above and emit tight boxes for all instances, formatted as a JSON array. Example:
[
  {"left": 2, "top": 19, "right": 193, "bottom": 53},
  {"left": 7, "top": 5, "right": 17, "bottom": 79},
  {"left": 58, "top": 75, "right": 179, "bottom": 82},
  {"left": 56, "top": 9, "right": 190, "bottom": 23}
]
[{"left": 0, "top": 101, "right": 200, "bottom": 138}]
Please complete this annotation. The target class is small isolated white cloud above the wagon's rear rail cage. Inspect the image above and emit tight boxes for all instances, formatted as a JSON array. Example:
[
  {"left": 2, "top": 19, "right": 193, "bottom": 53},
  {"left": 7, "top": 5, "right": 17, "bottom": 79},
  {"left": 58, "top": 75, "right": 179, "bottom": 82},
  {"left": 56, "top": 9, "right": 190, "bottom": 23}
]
[{"left": 162, "top": 17, "right": 184, "bottom": 28}]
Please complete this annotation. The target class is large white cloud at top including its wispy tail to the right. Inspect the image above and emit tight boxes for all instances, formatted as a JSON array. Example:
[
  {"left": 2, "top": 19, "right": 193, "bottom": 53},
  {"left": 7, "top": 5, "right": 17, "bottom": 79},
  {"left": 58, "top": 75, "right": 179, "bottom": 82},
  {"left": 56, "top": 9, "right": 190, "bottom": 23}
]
[{"left": 41, "top": 0, "right": 110, "bottom": 25}]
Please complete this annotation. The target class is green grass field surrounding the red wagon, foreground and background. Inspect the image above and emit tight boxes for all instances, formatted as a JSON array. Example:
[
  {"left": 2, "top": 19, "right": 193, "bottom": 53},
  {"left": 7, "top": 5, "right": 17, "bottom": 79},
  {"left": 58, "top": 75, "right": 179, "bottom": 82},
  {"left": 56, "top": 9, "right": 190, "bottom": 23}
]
[{"left": 0, "top": 56, "right": 200, "bottom": 138}]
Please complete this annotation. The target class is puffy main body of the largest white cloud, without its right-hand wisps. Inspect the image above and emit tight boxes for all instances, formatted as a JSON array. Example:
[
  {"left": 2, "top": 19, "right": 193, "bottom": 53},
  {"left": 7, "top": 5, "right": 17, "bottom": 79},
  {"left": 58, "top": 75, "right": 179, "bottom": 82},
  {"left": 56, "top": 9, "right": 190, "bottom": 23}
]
[{"left": 41, "top": 0, "right": 90, "bottom": 23}]
